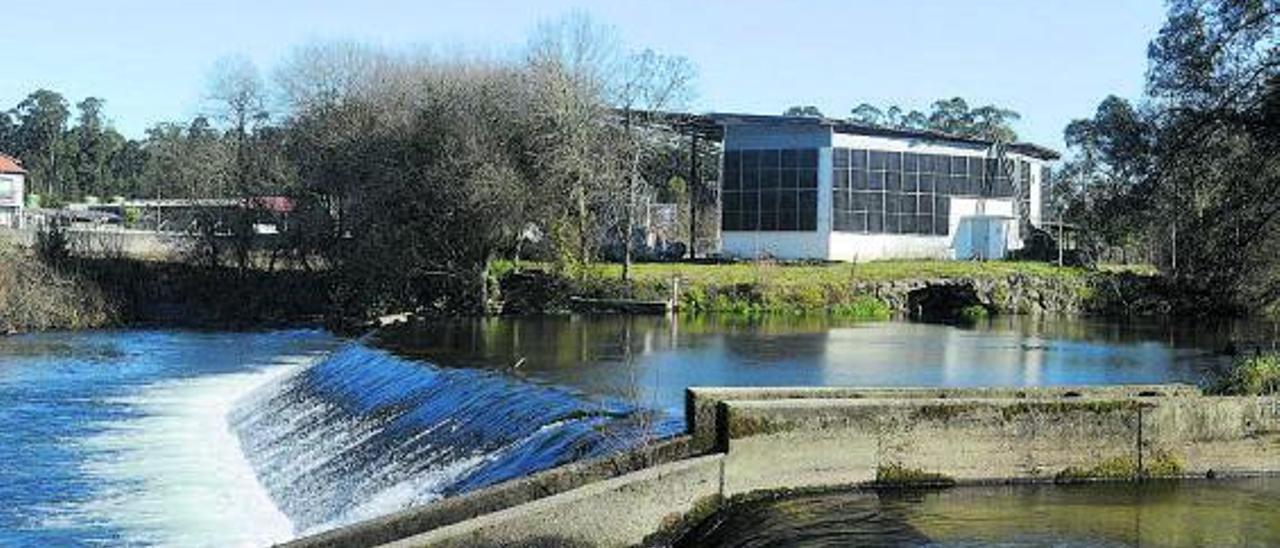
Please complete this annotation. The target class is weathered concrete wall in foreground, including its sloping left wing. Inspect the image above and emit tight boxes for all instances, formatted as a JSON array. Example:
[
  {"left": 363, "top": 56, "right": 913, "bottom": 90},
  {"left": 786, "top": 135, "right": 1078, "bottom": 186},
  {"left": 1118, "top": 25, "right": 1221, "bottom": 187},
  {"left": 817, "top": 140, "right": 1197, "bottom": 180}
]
[{"left": 292, "top": 385, "right": 1280, "bottom": 547}]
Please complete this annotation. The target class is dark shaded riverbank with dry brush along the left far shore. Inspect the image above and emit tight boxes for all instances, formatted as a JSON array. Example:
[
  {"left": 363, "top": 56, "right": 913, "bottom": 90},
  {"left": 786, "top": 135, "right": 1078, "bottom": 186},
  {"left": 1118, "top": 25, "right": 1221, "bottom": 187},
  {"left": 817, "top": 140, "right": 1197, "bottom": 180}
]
[{"left": 0, "top": 247, "right": 330, "bottom": 334}]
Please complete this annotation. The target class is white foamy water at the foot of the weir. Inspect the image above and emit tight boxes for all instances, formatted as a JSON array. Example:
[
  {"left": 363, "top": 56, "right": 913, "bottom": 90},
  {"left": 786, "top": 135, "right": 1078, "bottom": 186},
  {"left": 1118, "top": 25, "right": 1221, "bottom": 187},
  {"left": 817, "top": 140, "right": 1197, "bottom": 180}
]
[{"left": 70, "top": 357, "right": 307, "bottom": 547}]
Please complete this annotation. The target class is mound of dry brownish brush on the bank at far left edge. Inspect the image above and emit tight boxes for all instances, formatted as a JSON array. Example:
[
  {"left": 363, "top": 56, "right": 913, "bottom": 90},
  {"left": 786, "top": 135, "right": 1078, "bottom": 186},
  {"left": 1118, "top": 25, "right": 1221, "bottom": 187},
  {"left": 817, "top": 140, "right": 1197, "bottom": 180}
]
[{"left": 0, "top": 243, "right": 120, "bottom": 334}]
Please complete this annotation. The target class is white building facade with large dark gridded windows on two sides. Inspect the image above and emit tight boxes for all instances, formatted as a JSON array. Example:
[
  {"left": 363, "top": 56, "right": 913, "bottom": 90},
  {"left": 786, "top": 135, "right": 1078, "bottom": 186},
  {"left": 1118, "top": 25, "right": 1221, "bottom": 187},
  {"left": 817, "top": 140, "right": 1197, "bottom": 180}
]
[{"left": 712, "top": 115, "right": 1057, "bottom": 261}]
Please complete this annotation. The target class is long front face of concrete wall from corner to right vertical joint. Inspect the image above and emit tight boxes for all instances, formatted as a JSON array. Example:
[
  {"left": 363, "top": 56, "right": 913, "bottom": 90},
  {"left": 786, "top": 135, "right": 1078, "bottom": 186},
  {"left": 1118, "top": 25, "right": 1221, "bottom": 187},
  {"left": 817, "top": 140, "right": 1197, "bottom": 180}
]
[{"left": 723, "top": 398, "right": 1147, "bottom": 497}]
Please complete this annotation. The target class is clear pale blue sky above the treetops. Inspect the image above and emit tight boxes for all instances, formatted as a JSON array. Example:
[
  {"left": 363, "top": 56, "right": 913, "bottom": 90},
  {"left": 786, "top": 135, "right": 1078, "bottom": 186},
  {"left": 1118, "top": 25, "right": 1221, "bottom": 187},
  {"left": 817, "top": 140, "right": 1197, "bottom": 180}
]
[{"left": 0, "top": 0, "right": 1165, "bottom": 149}]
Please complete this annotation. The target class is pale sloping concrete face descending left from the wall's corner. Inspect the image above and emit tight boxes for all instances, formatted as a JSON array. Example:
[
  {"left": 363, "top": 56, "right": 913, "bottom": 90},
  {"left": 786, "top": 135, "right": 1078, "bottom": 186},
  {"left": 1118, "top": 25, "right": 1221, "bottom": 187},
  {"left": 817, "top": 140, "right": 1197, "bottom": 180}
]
[{"left": 388, "top": 455, "right": 723, "bottom": 548}]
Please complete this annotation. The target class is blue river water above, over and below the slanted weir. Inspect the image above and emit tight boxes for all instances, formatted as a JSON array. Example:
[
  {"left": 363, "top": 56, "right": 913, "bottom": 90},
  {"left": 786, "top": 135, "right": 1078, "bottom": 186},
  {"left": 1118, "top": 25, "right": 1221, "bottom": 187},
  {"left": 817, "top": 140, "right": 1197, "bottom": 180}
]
[{"left": 0, "top": 316, "right": 1274, "bottom": 545}]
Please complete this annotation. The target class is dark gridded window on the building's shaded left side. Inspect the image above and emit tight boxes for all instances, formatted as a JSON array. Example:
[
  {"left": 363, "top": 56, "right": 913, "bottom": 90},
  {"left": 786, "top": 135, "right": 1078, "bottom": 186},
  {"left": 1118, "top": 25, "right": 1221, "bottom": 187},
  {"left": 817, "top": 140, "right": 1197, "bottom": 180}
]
[{"left": 721, "top": 149, "right": 819, "bottom": 232}]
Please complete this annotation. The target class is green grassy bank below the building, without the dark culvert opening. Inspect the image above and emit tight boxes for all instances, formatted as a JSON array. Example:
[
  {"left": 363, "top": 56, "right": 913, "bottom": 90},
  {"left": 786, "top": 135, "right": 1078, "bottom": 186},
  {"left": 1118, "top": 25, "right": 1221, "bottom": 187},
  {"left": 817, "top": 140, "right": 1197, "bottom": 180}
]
[{"left": 498, "top": 261, "right": 1091, "bottom": 320}]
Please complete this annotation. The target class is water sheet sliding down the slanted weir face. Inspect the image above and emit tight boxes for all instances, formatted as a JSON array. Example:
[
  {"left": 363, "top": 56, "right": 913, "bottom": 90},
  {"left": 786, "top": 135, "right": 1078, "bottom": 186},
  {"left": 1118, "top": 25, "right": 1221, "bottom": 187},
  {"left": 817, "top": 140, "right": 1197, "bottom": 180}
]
[{"left": 230, "top": 343, "right": 682, "bottom": 534}]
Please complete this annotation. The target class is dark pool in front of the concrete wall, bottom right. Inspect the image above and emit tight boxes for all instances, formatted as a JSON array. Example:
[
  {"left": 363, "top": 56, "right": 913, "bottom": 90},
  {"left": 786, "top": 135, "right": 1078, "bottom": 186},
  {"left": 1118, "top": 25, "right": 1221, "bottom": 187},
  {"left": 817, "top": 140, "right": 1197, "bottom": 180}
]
[{"left": 676, "top": 478, "right": 1280, "bottom": 547}]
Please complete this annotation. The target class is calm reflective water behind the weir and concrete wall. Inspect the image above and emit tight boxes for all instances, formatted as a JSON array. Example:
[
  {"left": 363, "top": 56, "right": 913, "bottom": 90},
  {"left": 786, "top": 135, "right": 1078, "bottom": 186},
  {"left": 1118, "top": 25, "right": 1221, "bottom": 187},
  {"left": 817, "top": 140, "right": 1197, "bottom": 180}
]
[{"left": 376, "top": 316, "right": 1254, "bottom": 412}]
